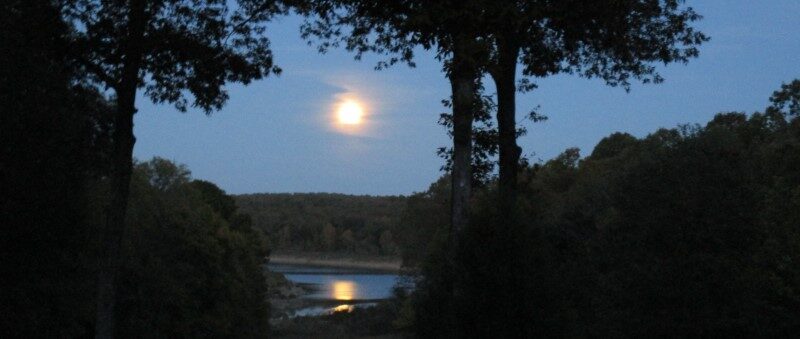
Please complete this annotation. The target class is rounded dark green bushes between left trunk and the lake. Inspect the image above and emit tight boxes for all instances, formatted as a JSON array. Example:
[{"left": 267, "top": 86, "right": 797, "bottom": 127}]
[{"left": 118, "top": 158, "right": 268, "bottom": 338}]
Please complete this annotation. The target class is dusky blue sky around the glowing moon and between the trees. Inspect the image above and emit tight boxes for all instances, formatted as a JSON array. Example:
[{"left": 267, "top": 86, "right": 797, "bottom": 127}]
[{"left": 134, "top": 0, "right": 800, "bottom": 195}]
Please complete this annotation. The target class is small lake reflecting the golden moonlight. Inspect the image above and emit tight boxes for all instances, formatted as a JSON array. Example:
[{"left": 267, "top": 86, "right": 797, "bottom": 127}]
[{"left": 267, "top": 264, "right": 399, "bottom": 316}]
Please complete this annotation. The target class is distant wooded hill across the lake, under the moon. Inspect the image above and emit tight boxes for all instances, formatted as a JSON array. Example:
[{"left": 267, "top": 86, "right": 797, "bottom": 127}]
[{"left": 236, "top": 193, "right": 406, "bottom": 255}]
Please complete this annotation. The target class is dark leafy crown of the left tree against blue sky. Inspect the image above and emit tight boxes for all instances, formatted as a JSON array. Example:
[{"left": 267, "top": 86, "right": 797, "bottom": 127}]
[{"left": 63, "top": 0, "right": 280, "bottom": 112}]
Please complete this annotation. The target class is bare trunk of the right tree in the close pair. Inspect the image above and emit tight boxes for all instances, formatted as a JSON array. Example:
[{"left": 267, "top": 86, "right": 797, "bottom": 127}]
[{"left": 491, "top": 42, "right": 522, "bottom": 222}]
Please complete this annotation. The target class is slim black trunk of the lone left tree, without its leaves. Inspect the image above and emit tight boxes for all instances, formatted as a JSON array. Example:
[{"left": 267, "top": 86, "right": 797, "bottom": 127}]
[{"left": 95, "top": 0, "right": 146, "bottom": 338}]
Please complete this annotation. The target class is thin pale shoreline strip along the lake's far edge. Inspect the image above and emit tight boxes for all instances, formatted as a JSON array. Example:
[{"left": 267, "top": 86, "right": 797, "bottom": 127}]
[{"left": 269, "top": 253, "right": 403, "bottom": 273}]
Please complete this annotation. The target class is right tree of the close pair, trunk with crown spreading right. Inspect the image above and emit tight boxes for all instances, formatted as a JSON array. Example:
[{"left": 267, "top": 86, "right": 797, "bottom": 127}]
[{"left": 482, "top": 0, "right": 708, "bottom": 222}]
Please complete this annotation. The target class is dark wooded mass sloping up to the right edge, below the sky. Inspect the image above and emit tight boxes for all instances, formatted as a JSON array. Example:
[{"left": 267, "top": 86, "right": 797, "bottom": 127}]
[{"left": 404, "top": 81, "right": 800, "bottom": 337}]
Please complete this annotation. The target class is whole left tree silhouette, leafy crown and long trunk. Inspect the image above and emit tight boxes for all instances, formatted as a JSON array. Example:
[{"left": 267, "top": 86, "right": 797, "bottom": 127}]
[{"left": 62, "top": 0, "right": 280, "bottom": 338}]
